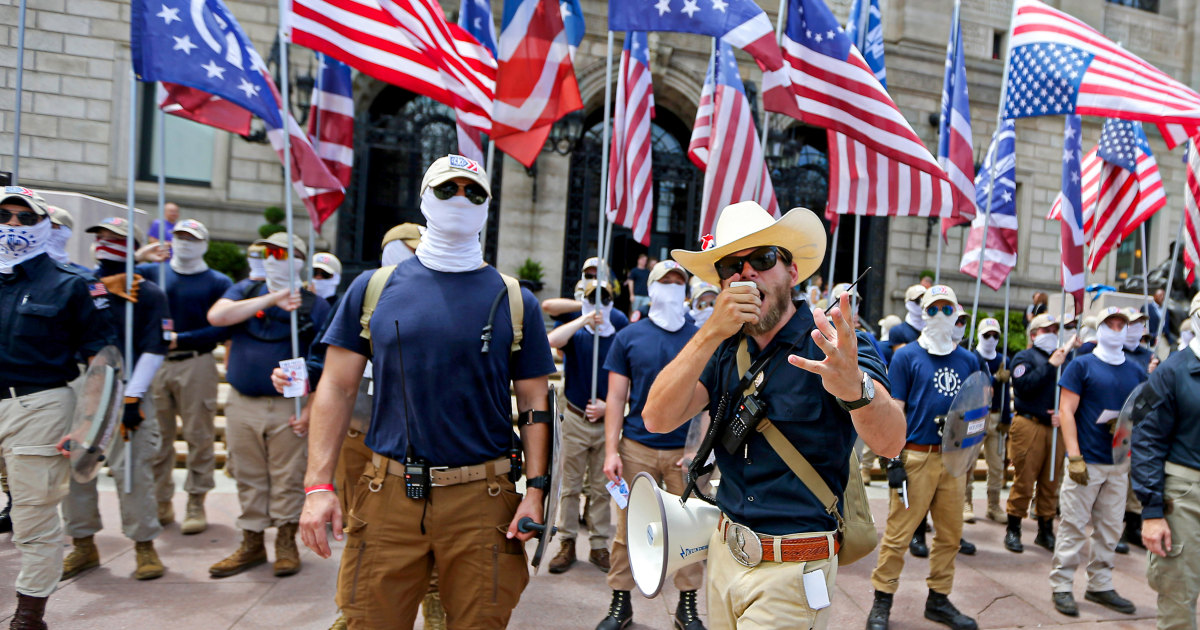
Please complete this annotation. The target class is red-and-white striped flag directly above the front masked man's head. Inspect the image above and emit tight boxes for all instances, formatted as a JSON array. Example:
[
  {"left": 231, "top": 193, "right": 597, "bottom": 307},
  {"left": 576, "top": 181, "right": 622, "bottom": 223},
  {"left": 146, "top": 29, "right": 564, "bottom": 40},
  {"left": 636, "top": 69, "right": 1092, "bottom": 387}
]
[{"left": 290, "top": 0, "right": 496, "bottom": 138}]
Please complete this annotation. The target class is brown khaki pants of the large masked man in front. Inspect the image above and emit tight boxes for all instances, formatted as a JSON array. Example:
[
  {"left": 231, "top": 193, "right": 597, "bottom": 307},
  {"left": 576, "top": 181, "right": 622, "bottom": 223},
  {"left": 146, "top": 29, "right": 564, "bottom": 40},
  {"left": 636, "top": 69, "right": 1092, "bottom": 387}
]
[{"left": 336, "top": 453, "right": 529, "bottom": 630}]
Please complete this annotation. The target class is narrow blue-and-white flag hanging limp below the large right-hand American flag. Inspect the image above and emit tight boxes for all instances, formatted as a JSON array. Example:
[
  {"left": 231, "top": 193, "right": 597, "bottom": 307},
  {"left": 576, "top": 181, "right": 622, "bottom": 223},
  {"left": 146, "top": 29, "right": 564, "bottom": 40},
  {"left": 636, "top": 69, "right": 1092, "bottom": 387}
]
[{"left": 959, "top": 119, "right": 1016, "bottom": 290}]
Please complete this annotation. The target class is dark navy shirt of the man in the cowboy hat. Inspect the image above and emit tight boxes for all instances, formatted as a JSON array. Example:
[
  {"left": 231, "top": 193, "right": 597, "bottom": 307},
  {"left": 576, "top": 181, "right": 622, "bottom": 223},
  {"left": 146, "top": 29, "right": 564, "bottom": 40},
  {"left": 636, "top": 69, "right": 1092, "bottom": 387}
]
[{"left": 700, "top": 302, "right": 888, "bottom": 535}]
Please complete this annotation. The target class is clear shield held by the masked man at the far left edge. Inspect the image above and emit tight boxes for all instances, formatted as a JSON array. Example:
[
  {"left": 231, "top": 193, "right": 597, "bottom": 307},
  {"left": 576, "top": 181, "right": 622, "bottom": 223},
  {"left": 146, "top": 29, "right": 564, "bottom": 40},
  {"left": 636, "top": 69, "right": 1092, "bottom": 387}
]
[{"left": 68, "top": 346, "right": 125, "bottom": 484}]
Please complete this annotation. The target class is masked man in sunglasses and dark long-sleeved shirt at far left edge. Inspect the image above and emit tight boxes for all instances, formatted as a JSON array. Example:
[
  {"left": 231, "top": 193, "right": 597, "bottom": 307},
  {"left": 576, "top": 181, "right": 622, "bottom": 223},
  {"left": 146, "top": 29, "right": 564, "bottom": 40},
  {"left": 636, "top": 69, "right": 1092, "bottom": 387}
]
[{"left": 0, "top": 186, "right": 116, "bottom": 629}]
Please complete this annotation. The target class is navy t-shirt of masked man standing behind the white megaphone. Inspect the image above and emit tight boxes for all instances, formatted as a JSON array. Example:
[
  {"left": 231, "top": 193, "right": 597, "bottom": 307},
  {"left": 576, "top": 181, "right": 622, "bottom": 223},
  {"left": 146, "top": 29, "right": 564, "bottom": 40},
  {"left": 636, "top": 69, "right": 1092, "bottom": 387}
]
[{"left": 604, "top": 316, "right": 698, "bottom": 450}]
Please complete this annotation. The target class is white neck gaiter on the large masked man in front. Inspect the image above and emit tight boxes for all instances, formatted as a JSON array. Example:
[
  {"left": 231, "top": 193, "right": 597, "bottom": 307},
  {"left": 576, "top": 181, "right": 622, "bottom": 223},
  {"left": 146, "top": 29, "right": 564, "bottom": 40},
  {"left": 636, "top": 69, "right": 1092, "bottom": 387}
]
[{"left": 416, "top": 190, "right": 491, "bottom": 274}]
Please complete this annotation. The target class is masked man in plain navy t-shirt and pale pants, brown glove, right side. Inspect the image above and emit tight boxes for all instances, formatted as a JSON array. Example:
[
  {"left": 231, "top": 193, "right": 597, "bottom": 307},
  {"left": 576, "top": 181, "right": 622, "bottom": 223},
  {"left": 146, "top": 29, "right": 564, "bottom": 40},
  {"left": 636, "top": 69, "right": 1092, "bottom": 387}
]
[{"left": 1050, "top": 306, "right": 1146, "bottom": 617}]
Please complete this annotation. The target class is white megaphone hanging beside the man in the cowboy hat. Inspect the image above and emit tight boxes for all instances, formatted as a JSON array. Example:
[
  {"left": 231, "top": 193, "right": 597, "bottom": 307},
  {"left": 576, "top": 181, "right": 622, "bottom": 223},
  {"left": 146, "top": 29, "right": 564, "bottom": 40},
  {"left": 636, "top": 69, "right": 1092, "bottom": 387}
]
[{"left": 625, "top": 473, "right": 721, "bottom": 598}]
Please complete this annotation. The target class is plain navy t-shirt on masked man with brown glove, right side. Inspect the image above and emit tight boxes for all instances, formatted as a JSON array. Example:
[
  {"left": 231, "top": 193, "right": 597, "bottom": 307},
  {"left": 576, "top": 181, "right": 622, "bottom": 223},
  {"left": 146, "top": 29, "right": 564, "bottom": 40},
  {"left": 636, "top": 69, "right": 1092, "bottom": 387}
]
[{"left": 1058, "top": 354, "right": 1147, "bottom": 464}]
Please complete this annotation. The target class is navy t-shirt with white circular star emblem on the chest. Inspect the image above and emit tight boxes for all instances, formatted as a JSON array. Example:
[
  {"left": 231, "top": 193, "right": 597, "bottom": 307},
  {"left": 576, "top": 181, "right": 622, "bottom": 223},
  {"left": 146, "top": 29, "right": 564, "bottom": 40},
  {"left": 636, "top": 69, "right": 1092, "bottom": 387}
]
[{"left": 888, "top": 343, "right": 983, "bottom": 444}]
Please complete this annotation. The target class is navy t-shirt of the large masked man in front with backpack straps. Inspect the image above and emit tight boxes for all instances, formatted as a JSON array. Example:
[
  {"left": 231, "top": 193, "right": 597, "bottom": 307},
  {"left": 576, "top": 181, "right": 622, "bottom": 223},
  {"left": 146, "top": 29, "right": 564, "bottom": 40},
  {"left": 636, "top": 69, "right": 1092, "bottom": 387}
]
[{"left": 323, "top": 257, "right": 554, "bottom": 466}]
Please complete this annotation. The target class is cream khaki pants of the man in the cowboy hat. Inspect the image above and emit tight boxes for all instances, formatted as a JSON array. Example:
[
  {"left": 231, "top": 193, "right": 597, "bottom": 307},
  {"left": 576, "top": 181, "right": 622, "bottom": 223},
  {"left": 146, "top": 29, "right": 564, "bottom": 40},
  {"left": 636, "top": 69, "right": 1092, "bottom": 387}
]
[{"left": 694, "top": 529, "right": 838, "bottom": 630}]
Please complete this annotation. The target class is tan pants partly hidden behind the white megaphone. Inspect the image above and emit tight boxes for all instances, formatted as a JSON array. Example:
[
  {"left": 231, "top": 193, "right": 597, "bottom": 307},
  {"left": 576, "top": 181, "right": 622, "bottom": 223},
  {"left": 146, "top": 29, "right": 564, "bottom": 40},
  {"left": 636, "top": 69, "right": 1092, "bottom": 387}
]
[{"left": 608, "top": 438, "right": 704, "bottom": 590}]
